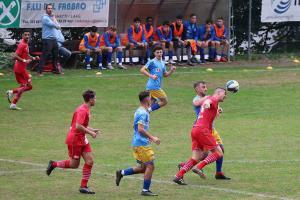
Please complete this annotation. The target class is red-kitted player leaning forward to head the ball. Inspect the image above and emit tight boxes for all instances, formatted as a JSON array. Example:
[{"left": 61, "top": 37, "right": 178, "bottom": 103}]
[{"left": 173, "top": 88, "right": 226, "bottom": 185}]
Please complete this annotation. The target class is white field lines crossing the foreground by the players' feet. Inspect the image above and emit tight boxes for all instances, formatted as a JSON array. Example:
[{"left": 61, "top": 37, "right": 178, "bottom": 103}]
[{"left": 0, "top": 159, "right": 292, "bottom": 200}]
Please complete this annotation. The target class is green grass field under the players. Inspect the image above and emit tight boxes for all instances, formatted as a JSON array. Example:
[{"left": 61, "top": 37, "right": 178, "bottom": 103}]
[{"left": 0, "top": 67, "right": 300, "bottom": 199}]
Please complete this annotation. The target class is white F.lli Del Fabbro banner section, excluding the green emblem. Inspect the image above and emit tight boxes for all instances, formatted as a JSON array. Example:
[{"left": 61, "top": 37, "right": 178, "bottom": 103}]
[{"left": 20, "top": 0, "right": 109, "bottom": 28}]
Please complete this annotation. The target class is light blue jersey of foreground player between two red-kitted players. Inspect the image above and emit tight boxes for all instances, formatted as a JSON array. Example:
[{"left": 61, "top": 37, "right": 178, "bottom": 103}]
[{"left": 132, "top": 107, "right": 150, "bottom": 147}]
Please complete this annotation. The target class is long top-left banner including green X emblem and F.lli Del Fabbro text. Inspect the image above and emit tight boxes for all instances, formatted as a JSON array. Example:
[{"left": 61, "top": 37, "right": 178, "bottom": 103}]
[{"left": 0, "top": 0, "right": 109, "bottom": 28}]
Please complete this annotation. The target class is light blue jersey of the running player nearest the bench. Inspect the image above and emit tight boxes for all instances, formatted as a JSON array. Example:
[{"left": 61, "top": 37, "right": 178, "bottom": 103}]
[{"left": 146, "top": 58, "right": 166, "bottom": 90}]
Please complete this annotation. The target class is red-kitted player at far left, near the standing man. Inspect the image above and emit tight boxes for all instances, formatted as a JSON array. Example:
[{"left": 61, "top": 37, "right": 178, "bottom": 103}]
[{"left": 6, "top": 30, "right": 39, "bottom": 110}]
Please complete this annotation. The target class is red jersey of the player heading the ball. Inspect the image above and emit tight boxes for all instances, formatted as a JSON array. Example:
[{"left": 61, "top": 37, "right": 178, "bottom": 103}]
[{"left": 194, "top": 96, "right": 219, "bottom": 130}]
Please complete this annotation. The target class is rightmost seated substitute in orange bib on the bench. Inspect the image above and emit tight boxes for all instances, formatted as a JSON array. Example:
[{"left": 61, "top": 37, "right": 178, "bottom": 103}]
[{"left": 213, "top": 17, "right": 229, "bottom": 62}]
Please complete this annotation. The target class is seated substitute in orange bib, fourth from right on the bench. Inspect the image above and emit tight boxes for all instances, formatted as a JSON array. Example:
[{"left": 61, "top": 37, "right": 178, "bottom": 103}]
[{"left": 171, "top": 15, "right": 184, "bottom": 65}]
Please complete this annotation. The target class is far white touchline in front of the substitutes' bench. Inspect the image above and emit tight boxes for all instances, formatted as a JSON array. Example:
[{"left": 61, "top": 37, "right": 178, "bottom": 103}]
[{"left": 0, "top": 68, "right": 300, "bottom": 81}]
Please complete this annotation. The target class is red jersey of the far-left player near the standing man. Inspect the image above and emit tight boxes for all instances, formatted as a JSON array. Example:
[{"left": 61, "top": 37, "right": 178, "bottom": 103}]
[{"left": 14, "top": 39, "right": 29, "bottom": 73}]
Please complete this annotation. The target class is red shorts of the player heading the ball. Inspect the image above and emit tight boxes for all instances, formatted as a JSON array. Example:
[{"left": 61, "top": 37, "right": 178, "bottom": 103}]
[{"left": 191, "top": 127, "right": 218, "bottom": 151}]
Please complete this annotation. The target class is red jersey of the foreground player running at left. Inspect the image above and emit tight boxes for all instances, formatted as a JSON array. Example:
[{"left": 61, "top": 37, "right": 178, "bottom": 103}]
[{"left": 66, "top": 104, "right": 90, "bottom": 146}]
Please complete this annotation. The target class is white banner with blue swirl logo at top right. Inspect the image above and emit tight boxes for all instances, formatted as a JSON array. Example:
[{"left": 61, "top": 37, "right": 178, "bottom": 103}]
[{"left": 261, "top": 0, "right": 300, "bottom": 22}]
